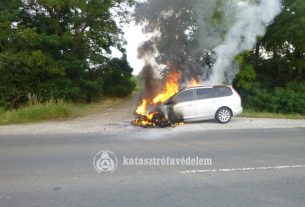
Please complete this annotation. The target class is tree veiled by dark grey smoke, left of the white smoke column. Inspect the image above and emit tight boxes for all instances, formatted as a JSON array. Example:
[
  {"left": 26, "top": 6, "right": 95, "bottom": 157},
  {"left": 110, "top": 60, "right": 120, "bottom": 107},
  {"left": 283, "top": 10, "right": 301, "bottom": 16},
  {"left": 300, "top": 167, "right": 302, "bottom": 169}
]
[{"left": 136, "top": 0, "right": 229, "bottom": 79}]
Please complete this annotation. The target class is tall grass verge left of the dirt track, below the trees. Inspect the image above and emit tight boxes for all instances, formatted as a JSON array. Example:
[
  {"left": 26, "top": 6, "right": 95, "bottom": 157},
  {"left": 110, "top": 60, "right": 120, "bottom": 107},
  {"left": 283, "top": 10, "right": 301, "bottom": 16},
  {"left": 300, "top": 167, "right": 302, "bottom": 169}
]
[{"left": 0, "top": 98, "right": 123, "bottom": 125}]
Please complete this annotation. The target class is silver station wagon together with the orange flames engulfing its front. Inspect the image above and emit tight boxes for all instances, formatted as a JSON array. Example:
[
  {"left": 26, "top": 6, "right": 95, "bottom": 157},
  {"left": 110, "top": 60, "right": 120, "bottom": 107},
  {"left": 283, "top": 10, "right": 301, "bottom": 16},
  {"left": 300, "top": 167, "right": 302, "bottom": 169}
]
[{"left": 132, "top": 71, "right": 243, "bottom": 127}]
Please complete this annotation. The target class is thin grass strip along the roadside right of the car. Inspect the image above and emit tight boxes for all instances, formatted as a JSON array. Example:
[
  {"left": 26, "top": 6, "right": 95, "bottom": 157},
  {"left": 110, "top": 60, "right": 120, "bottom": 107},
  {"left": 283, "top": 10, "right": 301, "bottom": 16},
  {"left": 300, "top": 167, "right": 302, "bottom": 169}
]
[{"left": 241, "top": 109, "right": 305, "bottom": 119}]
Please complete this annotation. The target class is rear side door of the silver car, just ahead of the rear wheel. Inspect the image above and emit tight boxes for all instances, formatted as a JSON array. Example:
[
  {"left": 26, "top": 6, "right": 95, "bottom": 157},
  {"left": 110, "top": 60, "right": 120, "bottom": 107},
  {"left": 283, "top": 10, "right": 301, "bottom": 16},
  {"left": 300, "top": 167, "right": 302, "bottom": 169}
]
[{"left": 195, "top": 88, "right": 216, "bottom": 119}]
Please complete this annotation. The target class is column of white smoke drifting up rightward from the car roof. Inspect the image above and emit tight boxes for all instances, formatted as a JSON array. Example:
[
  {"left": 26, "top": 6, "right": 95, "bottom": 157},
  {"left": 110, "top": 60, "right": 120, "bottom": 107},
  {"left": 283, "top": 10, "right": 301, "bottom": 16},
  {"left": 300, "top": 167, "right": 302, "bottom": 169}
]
[{"left": 209, "top": 0, "right": 282, "bottom": 84}]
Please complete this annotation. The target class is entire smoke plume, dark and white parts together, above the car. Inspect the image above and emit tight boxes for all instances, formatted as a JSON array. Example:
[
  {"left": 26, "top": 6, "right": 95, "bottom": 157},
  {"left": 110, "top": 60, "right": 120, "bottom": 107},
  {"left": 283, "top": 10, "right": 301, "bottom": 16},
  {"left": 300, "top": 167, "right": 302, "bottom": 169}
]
[{"left": 135, "top": 0, "right": 281, "bottom": 84}]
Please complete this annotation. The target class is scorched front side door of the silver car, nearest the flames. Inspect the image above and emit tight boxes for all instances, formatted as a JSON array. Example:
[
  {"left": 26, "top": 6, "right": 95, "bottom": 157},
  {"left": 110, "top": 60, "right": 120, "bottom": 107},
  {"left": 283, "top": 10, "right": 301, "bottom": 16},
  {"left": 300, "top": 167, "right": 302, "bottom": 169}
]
[{"left": 173, "top": 90, "right": 196, "bottom": 121}]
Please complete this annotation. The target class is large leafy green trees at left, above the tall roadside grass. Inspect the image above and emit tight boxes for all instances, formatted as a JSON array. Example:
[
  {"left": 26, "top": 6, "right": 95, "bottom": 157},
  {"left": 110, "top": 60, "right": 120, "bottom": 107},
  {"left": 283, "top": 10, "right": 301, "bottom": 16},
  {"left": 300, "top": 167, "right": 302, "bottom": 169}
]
[{"left": 0, "top": 0, "right": 132, "bottom": 107}]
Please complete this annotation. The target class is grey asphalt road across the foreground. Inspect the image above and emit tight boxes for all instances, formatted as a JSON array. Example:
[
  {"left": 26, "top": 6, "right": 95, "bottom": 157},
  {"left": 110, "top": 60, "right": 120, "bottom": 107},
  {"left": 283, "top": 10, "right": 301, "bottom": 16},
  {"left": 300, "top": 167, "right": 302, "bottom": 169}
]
[{"left": 0, "top": 128, "right": 305, "bottom": 207}]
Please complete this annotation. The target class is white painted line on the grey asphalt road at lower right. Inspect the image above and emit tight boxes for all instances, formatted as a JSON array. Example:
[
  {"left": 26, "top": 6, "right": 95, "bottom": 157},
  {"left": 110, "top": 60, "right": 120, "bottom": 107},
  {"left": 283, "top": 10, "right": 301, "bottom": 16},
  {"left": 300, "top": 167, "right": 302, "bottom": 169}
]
[{"left": 182, "top": 165, "right": 305, "bottom": 174}]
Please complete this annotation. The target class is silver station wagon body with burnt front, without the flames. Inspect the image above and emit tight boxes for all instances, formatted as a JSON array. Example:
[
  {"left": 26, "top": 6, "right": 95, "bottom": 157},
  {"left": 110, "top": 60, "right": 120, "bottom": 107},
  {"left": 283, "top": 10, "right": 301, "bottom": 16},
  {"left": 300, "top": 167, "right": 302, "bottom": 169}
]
[{"left": 157, "top": 85, "right": 243, "bottom": 123}]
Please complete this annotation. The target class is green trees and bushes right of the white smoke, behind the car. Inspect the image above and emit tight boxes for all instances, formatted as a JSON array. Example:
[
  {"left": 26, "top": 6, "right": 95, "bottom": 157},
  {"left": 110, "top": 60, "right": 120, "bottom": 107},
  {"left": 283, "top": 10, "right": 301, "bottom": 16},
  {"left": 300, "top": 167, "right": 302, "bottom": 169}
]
[{"left": 234, "top": 0, "right": 305, "bottom": 114}]
